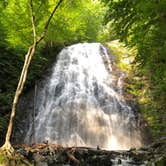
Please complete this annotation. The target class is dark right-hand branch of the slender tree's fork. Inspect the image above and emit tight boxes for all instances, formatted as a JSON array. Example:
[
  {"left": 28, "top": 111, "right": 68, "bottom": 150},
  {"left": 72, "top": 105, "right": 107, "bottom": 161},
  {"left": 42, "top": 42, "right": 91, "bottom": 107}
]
[{"left": 36, "top": 0, "right": 63, "bottom": 44}]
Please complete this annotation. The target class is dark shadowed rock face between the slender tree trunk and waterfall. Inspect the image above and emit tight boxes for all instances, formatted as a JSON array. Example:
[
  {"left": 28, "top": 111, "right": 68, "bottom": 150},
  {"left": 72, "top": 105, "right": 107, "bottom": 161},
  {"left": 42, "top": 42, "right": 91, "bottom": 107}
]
[{"left": 12, "top": 78, "right": 46, "bottom": 144}]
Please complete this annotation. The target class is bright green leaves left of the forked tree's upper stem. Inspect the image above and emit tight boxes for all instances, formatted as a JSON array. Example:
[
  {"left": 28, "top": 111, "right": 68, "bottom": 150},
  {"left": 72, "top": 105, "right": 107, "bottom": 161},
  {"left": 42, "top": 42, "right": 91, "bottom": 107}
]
[{"left": 2, "top": 0, "right": 31, "bottom": 46}]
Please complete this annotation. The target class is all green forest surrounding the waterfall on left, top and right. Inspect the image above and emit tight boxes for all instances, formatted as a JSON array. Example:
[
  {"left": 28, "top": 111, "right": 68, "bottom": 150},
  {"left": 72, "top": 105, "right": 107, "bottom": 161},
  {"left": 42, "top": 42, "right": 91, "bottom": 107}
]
[{"left": 0, "top": 0, "right": 166, "bottom": 145}]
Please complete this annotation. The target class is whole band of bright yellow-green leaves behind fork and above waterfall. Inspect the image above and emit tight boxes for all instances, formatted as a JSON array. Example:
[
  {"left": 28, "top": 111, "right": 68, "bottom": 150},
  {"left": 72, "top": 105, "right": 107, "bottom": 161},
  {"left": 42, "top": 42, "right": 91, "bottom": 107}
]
[{"left": 2, "top": 0, "right": 106, "bottom": 48}]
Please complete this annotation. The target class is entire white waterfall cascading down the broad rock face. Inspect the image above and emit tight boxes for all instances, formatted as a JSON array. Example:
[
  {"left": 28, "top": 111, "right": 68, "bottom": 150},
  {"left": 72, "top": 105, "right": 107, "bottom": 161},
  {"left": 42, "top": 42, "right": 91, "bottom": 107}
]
[{"left": 25, "top": 43, "right": 141, "bottom": 150}]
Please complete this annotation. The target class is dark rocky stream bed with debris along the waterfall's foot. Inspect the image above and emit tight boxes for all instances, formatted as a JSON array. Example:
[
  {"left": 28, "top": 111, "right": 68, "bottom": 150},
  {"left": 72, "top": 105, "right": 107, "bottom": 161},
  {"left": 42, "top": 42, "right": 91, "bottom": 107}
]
[{"left": 0, "top": 138, "right": 162, "bottom": 166}]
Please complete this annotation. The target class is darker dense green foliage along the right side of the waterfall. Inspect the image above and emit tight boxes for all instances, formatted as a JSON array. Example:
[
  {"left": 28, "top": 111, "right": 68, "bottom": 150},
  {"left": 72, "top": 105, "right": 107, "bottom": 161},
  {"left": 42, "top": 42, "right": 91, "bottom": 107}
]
[{"left": 103, "top": 0, "right": 166, "bottom": 136}]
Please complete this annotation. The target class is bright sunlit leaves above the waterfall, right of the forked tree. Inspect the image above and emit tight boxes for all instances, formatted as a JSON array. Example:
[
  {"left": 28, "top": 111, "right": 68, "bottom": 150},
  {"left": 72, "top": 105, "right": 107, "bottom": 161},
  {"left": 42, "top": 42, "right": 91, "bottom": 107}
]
[{"left": 47, "top": 0, "right": 105, "bottom": 44}]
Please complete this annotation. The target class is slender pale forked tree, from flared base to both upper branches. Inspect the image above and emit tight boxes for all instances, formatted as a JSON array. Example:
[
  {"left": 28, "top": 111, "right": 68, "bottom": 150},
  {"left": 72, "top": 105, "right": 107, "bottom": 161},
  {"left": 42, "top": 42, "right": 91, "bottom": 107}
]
[{"left": 1, "top": 0, "right": 63, "bottom": 151}]
